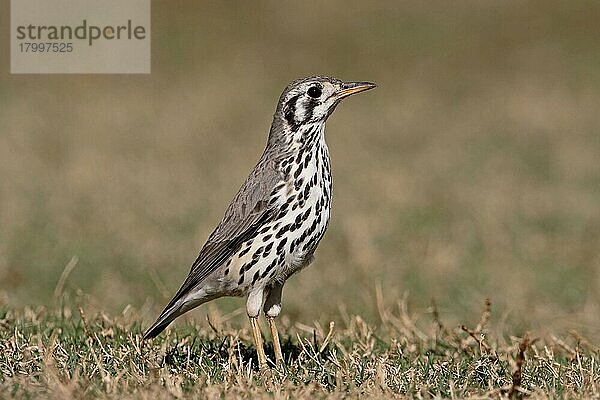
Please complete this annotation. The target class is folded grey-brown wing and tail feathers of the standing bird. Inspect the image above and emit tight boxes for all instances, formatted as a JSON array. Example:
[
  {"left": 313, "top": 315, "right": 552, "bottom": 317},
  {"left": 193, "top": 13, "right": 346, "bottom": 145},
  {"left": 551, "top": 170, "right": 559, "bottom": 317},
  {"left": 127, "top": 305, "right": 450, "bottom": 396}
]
[{"left": 144, "top": 156, "right": 282, "bottom": 338}]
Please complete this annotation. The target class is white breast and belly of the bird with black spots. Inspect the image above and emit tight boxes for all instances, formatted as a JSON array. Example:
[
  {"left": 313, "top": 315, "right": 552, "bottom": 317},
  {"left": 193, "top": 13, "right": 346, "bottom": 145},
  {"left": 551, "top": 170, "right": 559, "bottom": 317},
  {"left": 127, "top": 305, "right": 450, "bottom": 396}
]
[{"left": 214, "top": 125, "right": 332, "bottom": 295}]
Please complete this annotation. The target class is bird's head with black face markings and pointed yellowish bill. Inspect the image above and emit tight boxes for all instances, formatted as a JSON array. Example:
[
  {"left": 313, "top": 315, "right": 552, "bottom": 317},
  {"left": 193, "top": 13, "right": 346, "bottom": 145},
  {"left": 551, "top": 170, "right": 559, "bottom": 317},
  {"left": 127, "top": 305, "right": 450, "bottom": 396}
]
[{"left": 275, "top": 76, "right": 377, "bottom": 131}]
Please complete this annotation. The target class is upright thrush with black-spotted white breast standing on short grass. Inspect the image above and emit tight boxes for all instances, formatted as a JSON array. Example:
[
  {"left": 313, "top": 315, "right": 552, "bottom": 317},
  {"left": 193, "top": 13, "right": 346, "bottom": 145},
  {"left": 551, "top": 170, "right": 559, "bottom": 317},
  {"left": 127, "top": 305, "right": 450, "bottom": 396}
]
[{"left": 144, "top": 76, "right": 377, "bottom": 370}]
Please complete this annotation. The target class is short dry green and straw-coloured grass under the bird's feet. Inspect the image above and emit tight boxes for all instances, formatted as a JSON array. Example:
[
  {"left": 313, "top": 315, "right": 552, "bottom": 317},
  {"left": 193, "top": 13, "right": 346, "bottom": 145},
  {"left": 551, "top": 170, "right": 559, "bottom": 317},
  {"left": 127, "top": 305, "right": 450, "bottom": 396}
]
[{"left": 0, "top": 302, "right": 600, "bottom": 399}]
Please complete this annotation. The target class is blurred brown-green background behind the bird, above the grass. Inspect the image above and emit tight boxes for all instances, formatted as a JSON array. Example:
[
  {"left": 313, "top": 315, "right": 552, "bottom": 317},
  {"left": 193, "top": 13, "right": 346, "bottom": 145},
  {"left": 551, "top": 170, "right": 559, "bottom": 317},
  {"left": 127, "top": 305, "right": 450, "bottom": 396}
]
[{"left": 0, "top": 0, "right": 600, "bottom": 338}]
